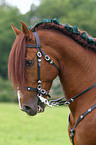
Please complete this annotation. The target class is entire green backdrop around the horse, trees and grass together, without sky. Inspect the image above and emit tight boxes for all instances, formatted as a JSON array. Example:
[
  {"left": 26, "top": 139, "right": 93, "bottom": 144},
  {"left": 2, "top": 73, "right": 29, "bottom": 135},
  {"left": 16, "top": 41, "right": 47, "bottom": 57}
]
[{"left": 0, "top": 0, "right": 96, "bottom": 145}]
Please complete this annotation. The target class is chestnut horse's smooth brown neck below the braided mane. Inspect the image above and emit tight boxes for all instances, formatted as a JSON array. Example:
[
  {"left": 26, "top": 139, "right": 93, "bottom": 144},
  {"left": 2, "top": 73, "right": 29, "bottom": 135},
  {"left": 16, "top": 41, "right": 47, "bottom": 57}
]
[{"left": 40, "top": 30, "right": 96, "bottom": 118}]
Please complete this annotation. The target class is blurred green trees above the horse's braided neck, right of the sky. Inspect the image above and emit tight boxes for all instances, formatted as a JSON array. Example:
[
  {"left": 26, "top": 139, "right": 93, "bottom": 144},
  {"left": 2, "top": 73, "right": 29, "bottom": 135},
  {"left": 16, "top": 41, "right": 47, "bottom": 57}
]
[{"left": 26, "top": 0, "right": 96, "bottom": 36}]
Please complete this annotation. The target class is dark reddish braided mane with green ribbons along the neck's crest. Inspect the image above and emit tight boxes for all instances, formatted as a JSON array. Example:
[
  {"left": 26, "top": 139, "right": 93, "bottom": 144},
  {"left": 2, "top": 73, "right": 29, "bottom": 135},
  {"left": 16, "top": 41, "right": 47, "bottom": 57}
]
[{"left": 28, "top": 18, "right": 96, "bottom": 52}]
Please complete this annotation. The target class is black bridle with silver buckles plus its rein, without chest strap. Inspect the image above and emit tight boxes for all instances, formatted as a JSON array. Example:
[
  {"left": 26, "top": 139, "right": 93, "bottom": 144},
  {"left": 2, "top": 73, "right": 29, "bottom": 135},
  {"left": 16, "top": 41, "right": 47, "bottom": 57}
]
[{"left": 26, "top": 31, "right": 96, "bottom": 107}]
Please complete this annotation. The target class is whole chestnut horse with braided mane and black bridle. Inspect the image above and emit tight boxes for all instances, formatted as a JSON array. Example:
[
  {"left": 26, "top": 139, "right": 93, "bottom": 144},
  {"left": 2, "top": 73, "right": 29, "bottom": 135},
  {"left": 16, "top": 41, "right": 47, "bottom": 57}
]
[{"left": 8, "top": 18, "right": 96, "bottom": 145}]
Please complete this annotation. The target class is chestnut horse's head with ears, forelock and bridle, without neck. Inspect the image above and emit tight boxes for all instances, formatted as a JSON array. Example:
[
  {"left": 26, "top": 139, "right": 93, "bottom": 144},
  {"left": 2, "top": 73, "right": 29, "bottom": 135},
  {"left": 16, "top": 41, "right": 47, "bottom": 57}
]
[{"left": 8, "top": 22, "right": 59, "bottom": 116}]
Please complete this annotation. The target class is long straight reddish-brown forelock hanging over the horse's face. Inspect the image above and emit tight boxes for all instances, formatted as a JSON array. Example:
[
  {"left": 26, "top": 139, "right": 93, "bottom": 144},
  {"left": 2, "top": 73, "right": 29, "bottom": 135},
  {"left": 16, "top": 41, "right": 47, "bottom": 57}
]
[{"left": 8, "top": 33, "right": 26, "bottom": 89}]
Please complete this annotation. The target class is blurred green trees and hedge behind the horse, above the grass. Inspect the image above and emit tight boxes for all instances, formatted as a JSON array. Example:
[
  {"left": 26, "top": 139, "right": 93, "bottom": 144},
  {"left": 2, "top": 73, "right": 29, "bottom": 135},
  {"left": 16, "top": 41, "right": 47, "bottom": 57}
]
[{"left": 0, "top": 0, "right": 96, "bottom": 102}]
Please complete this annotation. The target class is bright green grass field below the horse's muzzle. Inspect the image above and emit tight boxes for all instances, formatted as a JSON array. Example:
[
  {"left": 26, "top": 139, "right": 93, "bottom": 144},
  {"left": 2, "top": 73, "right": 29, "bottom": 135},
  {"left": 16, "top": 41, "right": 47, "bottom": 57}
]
[{"left": 0, "top": 103, "right": 71, "bottom": 145}]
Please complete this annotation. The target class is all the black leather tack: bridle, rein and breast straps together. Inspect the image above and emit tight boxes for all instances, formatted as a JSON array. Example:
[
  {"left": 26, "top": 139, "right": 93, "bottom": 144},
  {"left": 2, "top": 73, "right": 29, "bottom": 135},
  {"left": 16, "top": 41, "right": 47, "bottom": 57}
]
[{"left": 26, "top": 31, "right": 96, "bottom": 145}]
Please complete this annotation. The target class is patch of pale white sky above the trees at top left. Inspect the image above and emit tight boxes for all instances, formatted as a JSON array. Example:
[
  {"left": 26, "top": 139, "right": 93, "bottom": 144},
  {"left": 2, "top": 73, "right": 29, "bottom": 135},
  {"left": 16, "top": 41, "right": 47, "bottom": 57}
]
[{"left": 6, "top": 0, "right": 39, "bottom": 14}]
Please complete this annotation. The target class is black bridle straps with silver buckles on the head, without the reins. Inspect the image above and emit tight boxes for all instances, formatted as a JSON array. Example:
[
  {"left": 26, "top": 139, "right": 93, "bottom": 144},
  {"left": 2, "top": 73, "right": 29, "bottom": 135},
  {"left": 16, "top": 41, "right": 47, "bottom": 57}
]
[{"left": 26, "top": 31, "right": 60, "bottom": 107}]
